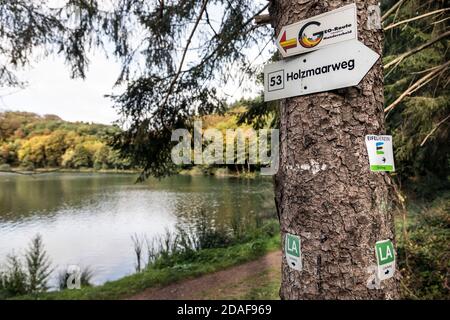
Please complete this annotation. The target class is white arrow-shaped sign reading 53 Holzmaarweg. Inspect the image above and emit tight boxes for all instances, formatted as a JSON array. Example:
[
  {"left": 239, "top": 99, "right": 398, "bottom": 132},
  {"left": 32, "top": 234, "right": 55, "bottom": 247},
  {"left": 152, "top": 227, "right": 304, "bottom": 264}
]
[{"left": 264, "top": 40, "right": 380, "bottom": 101}]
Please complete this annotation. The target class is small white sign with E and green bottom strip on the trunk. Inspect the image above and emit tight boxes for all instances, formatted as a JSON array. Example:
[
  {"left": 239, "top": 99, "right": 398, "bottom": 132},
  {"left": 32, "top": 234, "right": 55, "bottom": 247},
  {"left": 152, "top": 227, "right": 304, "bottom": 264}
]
[{"left": 366, "top": 135, "right": 395, "bottom": 172}]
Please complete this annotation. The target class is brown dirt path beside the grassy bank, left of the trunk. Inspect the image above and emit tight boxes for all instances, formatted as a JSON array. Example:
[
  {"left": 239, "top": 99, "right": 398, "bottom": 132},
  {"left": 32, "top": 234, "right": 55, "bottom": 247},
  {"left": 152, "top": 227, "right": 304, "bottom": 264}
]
[{"left": 129, "top": 251, "right": 281, "bottom": 300}]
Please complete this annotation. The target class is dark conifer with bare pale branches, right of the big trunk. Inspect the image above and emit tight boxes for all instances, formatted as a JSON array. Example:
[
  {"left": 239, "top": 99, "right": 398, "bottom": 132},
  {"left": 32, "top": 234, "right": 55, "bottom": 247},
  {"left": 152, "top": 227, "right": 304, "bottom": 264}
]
[{"left": 383, "top": 0, "right": 450, "bottom": 194}]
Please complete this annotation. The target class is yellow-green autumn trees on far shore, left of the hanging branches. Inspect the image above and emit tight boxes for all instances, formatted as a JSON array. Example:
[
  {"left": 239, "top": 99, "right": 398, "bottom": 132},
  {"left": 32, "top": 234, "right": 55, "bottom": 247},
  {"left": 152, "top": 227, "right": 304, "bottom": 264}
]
[{"left": 0, "top": 111, "right": 130, "bottom": 170}]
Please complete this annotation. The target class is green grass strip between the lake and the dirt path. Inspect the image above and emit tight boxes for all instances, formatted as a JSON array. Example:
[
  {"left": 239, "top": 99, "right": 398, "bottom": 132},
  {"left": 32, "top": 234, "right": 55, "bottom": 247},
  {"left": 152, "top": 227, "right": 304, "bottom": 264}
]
[{"left": 14, "top": 234, "right": 280, "bottom": 300}]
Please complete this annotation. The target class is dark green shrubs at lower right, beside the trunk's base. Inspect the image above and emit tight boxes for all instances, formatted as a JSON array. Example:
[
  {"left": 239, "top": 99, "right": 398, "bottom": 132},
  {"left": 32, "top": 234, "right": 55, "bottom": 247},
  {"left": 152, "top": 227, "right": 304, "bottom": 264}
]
[{"left": 397, "top": 195, "right": 450, "bottom": 299}]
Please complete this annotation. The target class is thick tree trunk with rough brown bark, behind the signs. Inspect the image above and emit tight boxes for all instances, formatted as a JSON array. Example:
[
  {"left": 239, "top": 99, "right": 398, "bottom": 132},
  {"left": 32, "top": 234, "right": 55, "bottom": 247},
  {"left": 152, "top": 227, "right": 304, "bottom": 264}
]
[{"left": 269, "top": 0, "right": 399, "bottom": 299}]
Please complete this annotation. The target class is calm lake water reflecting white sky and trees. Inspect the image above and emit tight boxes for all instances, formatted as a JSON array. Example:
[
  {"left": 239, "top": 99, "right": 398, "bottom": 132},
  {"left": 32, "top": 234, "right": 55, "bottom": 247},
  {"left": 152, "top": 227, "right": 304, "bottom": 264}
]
[{"left": 0, "top": 173, "right": 275, "bottom": 284}]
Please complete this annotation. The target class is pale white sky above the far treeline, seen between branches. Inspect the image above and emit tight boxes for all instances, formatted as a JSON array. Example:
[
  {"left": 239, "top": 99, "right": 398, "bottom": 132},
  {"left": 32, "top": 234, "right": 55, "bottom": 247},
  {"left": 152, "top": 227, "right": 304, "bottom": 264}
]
[{"left": 0, "top": 2, "right": 267, "bottom": 124}]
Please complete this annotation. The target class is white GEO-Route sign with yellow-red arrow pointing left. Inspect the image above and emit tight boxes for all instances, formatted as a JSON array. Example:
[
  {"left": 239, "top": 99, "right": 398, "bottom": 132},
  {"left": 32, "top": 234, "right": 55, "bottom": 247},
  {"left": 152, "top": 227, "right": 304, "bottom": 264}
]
[{"left": 277, "top": 3, "right": 358, "bottom": 57}]
